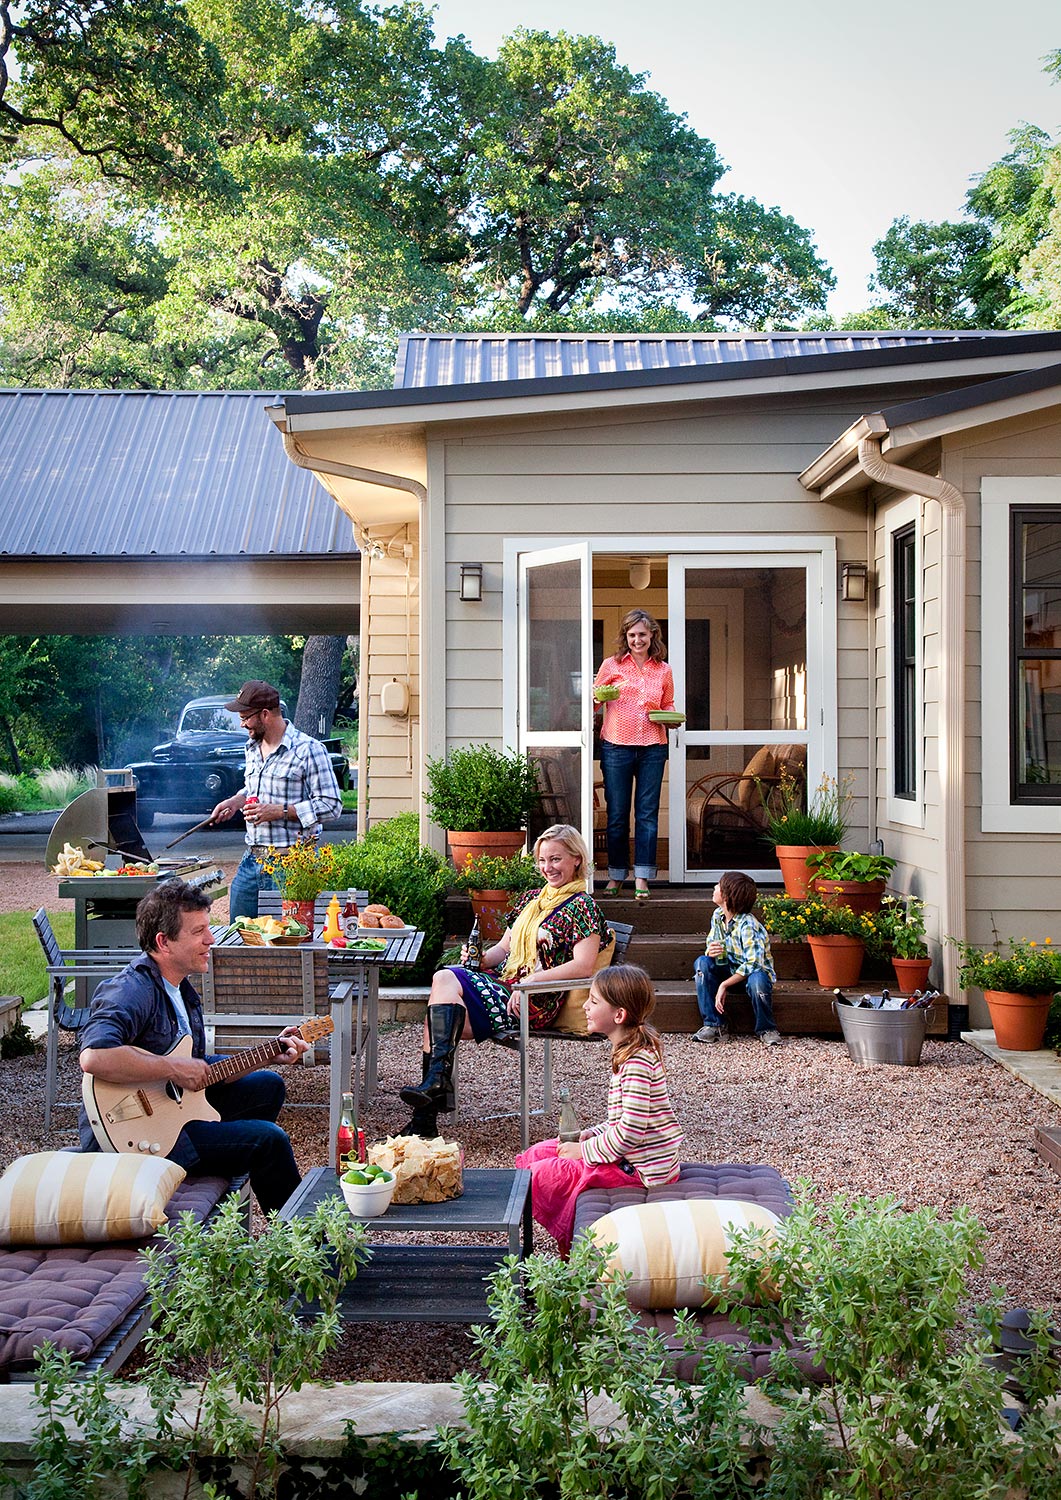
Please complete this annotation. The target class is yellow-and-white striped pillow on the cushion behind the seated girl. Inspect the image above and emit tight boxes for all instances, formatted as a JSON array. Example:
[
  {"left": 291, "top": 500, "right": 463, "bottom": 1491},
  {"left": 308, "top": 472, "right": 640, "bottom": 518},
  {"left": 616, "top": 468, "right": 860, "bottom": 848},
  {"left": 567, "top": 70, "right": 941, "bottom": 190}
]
[{"left": 588, "top": 1199, "right": 780, "bottom": 1308}]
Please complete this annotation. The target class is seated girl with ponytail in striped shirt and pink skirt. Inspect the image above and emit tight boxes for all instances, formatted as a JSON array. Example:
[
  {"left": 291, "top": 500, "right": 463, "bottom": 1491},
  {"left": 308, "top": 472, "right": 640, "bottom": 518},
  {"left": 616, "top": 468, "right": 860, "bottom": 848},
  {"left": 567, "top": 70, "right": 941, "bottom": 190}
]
[{"left": 516, "top": 965, "right": 683, "bottom": 1257}]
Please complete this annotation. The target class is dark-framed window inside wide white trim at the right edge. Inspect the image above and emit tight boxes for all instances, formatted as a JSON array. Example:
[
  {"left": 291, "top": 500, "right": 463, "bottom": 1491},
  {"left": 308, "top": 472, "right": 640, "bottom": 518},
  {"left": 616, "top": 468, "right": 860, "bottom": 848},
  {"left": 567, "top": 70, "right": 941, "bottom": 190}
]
[{"left": 1008, "top": 506, "right": 1061, "bottom": 807}]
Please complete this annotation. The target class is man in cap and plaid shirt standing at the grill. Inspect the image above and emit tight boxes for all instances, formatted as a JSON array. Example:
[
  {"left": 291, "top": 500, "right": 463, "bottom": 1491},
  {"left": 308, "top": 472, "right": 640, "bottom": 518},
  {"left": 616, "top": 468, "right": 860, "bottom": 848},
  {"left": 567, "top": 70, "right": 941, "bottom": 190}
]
[{"left": 210, "top": 681, "right": 342, "bottom": 921}]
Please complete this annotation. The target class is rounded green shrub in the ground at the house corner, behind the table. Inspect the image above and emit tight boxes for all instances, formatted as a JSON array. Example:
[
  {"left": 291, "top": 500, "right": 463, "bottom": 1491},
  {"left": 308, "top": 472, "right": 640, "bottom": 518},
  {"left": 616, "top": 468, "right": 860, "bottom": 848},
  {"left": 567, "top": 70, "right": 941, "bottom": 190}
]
[{"left": 333, "top": 813, "right": 453, "bottom": 983}]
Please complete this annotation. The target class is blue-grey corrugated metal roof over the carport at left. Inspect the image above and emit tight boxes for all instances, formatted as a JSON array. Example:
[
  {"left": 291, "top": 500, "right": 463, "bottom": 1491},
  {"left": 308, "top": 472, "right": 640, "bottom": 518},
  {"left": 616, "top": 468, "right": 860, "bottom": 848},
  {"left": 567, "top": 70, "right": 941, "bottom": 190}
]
[{"left": 0, "top": 390, "right": 357, "bottom": 557}]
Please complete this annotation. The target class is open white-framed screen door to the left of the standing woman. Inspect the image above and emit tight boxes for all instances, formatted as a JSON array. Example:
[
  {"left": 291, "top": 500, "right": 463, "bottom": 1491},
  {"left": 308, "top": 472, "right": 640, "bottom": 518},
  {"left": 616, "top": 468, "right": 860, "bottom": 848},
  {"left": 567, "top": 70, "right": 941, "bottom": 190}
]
[{"left": 516, "top": 543, "right": 593, "bottom": 882}]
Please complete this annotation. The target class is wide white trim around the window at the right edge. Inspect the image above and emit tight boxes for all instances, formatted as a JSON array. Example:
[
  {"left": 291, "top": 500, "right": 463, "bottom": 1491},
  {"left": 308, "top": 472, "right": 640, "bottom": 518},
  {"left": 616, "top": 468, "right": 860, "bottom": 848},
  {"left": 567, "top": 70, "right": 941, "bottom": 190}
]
[{"left": 980, "top": 476, "right": 1061, "bottom": 834}]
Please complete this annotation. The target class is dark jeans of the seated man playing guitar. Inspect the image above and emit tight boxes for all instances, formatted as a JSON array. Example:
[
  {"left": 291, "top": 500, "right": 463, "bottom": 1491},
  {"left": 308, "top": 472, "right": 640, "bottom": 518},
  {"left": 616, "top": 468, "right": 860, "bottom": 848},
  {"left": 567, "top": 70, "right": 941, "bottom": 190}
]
[{"left": 170, "top": 1058, "right": 302, "bottom": 1214}]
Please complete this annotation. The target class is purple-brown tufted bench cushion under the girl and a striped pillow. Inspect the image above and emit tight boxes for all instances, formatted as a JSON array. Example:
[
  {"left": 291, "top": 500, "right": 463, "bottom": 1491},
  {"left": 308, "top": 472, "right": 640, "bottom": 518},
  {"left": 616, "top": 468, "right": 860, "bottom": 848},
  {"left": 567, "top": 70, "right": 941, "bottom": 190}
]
[{"left": 575, "top": 1163, "right": 825, "bottom": 1382}]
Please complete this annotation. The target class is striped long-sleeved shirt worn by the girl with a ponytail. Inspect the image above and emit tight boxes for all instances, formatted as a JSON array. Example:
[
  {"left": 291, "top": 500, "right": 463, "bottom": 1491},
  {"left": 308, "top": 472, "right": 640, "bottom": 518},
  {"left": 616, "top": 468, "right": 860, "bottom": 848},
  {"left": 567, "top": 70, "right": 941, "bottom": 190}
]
[{"left": 582, "top": 1049, "right": 684, "bottom": 1188}]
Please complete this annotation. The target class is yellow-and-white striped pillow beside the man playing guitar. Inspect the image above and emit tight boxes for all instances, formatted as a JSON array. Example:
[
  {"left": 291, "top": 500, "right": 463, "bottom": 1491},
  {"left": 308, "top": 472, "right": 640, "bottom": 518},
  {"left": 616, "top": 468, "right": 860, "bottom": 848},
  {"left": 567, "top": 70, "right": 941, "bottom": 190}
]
[{"left": 0, "top": 1151, "right": 185, "bottom": 1245}]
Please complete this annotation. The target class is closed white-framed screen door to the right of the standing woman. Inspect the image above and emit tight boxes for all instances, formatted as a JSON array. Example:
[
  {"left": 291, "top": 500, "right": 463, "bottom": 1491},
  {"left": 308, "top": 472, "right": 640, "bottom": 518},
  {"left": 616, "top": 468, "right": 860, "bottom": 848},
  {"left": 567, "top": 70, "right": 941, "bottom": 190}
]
[{"left": 668, "top": 554, "right": 824, "bottom": 884}]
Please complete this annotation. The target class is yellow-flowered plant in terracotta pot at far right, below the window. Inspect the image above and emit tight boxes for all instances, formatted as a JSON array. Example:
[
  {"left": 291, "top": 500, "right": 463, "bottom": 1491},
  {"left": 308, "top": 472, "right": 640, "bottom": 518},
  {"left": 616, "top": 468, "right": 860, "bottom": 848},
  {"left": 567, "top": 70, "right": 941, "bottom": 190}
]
[{"left": 947, "top": 935, "right": 1061, "bottom": 1052}]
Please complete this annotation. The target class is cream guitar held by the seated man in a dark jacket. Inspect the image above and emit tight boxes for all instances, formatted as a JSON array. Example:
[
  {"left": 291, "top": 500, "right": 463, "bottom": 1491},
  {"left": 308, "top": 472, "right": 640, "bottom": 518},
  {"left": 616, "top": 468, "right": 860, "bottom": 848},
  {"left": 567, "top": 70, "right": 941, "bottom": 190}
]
[{"left": 81, "top": 1016, "right": 335, "bottom": 1157}]
